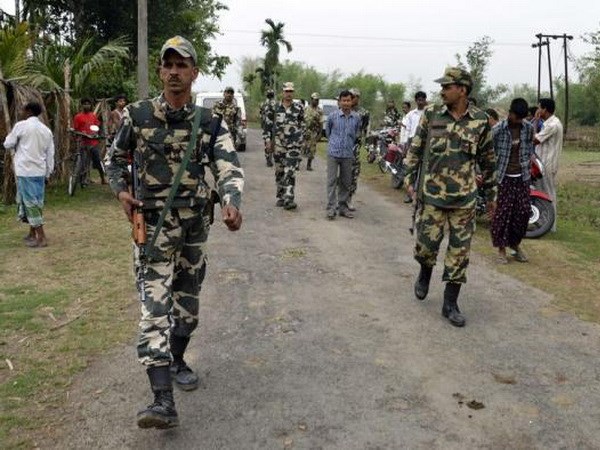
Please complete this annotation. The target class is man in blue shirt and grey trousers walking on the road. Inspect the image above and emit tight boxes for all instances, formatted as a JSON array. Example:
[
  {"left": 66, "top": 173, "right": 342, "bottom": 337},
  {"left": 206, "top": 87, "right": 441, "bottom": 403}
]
[{"left": 325, "top": 90, "right": 361, "bottom": 220}]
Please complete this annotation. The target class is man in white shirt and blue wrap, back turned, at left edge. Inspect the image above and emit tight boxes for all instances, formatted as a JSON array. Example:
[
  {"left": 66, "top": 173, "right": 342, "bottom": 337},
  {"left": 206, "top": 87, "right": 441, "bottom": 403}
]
[{"left": 4, "top": 101, "right": 54, "bottom": 247}]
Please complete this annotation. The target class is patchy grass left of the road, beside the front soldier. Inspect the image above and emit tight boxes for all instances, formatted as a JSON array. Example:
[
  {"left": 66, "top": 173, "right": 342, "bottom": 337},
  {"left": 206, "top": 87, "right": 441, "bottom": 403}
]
[{"left": 0, "top": 178, "right": 137, "bottom": 448}]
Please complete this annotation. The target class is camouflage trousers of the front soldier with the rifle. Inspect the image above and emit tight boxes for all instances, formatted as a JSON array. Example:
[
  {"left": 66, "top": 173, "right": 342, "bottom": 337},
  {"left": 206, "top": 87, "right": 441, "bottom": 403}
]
[{"left": 134, "top": 208, "right": 209, "bottom": 366}]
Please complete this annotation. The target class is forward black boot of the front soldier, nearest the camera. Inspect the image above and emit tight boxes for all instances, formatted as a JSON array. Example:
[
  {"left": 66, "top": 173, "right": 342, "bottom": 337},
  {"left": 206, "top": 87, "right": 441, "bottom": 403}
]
[{"left": 137, "top": 366, "right": 179, "bottom": 428}]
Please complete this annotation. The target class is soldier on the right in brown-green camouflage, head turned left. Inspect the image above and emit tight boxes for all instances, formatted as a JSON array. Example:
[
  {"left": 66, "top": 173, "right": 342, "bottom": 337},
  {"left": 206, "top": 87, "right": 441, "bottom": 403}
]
[{"left": 405, "top": 67, "right": 496, "bottom": 327}]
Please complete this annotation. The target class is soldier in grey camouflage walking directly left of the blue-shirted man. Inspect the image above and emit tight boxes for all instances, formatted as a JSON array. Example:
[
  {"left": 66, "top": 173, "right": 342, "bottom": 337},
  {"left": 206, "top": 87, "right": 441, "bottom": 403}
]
[{"left": 263, "top": 82, "right": 304, "bottom": 210}]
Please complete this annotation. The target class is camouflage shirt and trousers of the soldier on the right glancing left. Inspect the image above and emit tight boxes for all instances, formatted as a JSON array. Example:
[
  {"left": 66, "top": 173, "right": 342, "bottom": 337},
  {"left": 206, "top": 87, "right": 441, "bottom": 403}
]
[{"left": 405, "top": 105, "right": 496, "bottom": 283}]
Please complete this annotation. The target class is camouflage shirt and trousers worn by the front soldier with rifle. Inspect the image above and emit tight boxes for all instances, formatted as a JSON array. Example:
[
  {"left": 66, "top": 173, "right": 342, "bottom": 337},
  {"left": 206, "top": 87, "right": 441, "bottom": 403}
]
[{"left": 107, "top": 95, "right": 244, "bottom": 366}]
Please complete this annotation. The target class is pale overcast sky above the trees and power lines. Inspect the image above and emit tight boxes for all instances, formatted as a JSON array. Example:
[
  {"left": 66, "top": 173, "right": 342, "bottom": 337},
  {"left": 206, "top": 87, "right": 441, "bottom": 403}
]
[{"left": 0, "top": 0, "right": 600, "bottom": 94}]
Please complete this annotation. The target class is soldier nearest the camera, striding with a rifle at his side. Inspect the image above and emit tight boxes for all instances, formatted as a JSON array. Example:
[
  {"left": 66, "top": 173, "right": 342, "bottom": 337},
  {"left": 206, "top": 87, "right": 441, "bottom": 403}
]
[{"left": 107, "top": 36, "right": 244, "bottom": 428}]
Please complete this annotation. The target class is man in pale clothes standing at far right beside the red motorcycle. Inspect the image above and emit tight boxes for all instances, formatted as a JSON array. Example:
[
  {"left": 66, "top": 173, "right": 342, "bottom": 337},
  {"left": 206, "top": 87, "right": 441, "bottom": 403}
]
[{"left": 533, "top": 98, "right": 563, "bottom": 232}]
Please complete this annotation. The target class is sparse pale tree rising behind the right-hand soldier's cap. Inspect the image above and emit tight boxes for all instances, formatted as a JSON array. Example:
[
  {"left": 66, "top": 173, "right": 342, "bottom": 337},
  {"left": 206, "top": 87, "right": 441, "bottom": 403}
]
[{"left": 456, "top": 36, "right": 508, "bottom": 107}]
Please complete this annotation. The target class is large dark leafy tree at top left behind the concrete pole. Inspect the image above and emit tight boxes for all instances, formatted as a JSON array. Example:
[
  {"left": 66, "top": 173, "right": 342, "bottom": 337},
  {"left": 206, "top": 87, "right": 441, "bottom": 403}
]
[{"left": 23, "top": 0, "right": 230, "bottom": 77}]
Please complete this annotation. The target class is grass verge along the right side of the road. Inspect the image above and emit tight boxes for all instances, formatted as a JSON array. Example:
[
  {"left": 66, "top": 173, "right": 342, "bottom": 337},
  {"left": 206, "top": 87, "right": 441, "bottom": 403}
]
[{"left": 318, "top": 143, "right": 600, "bottom": 323}]
